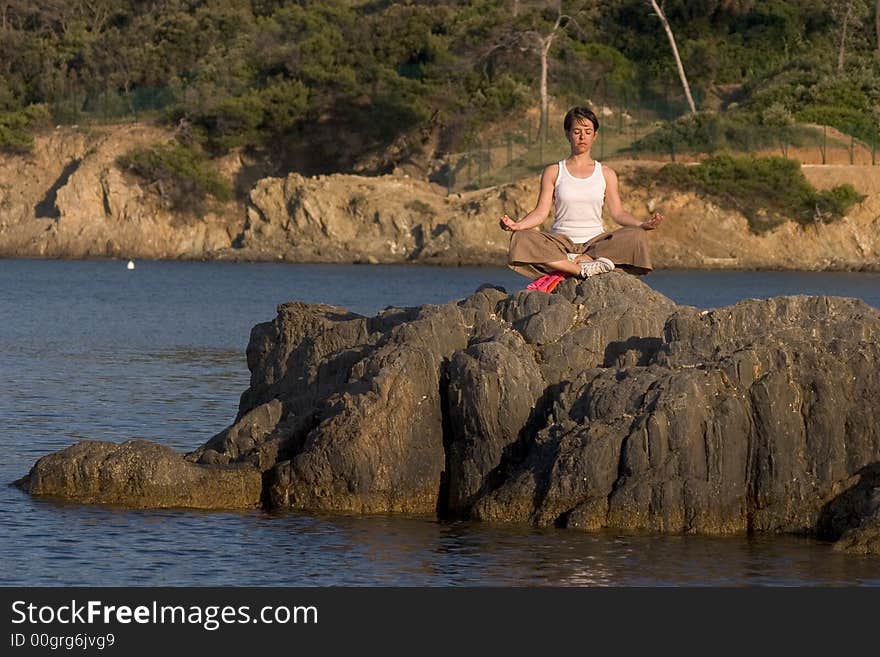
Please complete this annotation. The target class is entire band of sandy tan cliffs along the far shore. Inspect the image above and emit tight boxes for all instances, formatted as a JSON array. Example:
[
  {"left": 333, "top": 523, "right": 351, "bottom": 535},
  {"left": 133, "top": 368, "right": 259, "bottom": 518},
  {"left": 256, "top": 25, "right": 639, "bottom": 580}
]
[{"left": 0, "top": 125, "right": 880, "bottom": 271}]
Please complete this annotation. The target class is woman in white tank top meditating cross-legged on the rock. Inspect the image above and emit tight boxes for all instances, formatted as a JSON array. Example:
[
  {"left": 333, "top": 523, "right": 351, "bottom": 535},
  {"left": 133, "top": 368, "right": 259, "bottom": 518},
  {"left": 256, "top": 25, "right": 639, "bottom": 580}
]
[{"left": 501, "top": 107, "right": 663, "bottom": 278}]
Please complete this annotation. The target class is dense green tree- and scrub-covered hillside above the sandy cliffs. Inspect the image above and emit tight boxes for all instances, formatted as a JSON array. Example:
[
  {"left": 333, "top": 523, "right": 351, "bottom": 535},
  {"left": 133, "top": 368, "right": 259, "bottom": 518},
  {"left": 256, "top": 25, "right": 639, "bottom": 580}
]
[{"left": 0, "top": 0, "right": 880, "bottom": 182}]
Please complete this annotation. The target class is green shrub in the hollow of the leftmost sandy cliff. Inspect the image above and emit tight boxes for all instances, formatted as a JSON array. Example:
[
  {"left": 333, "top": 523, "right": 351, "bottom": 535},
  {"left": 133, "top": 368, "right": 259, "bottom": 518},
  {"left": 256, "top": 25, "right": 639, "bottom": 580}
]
[{"left": 117, "top": 141, "right": 232, "bottom": 213}]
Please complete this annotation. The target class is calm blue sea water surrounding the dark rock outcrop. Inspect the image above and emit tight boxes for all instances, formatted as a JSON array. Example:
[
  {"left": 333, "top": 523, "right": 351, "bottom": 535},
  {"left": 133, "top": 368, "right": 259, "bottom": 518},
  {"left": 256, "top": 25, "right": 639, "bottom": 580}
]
[{"left": 0, "top": 260, "right": 880, "bottom": 586}]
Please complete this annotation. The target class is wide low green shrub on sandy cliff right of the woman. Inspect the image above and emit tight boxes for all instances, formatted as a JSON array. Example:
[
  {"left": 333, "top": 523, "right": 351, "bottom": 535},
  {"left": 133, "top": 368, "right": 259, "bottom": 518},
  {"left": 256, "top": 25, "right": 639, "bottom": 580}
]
[{"left": 656, "top": 155, "right": 864, "bottom": 233}]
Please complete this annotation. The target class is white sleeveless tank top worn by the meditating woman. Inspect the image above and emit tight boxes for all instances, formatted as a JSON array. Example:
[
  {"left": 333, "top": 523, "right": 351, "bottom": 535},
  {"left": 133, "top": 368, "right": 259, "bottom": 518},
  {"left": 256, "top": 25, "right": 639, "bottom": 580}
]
[{"left": 551, "top": 160, "right": 605, "bottom": 244}]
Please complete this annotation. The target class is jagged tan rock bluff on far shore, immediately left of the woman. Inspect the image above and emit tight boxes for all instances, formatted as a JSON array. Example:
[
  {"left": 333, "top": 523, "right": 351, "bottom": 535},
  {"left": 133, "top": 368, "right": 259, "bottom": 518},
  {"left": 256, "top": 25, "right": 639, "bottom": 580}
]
[{"left": 232, "top": 174, "right": 534, "bottom": 265}]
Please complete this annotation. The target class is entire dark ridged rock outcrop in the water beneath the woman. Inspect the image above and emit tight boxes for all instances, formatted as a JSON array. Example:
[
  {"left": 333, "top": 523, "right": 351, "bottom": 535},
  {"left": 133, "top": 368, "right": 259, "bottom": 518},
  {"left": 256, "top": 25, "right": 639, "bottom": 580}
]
[{"left": 19, "top": 272, "right": 880, "bottom": 553}]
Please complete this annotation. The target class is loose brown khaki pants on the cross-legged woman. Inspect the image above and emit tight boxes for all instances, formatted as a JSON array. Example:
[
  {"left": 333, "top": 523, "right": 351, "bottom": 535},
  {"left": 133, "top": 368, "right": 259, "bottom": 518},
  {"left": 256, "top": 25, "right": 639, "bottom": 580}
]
[{"left": 507, "top": 226, "right": 653, "bottom": 278}]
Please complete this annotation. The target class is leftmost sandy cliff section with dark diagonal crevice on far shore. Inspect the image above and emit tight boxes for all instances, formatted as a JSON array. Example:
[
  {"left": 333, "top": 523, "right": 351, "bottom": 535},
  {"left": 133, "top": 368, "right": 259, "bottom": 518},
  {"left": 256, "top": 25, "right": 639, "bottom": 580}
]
[{"left": 0, "top": 125, "right": 240, "bottom": 258}]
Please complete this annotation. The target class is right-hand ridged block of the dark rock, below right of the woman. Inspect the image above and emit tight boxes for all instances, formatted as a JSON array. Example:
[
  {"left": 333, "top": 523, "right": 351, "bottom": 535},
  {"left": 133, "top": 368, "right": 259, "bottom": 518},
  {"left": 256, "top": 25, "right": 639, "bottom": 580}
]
[{"left": 472, "top": 297, "right": 880, "bottom": 535}]
